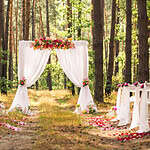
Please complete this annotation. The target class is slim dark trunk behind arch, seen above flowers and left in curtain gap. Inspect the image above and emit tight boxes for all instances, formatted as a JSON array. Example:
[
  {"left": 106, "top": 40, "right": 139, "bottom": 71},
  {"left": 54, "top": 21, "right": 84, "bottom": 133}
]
[{"left": 46, "top": 0, "right": 52, "bottom": 90}]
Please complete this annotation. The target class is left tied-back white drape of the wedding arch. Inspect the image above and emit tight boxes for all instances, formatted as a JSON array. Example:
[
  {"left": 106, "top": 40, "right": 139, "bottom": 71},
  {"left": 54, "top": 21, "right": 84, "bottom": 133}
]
[{"left": 9, "top": 41, "right": 50, "bottom": 111}]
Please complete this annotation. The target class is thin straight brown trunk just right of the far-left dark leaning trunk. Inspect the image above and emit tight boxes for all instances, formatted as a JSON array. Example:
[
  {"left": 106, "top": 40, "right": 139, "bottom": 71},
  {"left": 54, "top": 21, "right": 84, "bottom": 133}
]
[{"left": 8, "top": 0, "right": 13, "bottom": 87}]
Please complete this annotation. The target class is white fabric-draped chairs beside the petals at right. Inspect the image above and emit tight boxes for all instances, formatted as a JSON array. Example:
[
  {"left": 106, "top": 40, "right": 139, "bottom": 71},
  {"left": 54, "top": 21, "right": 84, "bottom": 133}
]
[{"left": 117, "top": 82, "right": 150, "bottom": 132}]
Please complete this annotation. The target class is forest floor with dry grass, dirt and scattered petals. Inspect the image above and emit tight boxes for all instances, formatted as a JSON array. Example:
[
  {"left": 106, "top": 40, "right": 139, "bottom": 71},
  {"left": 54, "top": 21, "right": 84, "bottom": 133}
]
[{"left": 0, "top": 89, "right": 150, "bottom": 150}]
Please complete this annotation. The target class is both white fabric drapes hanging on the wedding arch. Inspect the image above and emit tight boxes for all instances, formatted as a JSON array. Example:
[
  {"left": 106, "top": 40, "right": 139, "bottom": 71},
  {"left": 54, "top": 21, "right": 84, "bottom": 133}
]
[{"left": 9, "top": 41, "right": 94, "bottom": 112}]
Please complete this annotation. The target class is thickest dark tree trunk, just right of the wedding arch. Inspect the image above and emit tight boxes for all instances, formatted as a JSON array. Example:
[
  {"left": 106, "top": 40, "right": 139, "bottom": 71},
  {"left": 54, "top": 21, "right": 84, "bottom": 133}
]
[{"left": 93, "top": 0, "right": 104, "bottom": 102}]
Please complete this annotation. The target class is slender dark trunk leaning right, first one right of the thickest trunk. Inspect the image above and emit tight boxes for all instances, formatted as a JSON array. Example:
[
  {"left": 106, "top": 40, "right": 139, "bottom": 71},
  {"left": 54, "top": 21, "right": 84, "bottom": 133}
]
[{"left": 105, "top": 0, "right": 116, "bottom": 95}]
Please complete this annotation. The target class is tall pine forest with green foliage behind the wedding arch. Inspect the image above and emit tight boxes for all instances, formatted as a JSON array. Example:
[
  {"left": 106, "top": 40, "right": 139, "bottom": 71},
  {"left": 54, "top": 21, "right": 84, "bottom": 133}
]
[{"left": 0, "top": 0, "right": 150, "bottom": 102}]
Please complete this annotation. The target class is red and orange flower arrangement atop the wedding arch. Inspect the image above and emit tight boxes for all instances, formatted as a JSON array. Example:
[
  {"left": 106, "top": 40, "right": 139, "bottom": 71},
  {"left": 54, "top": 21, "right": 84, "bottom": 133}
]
[{"left": 31, "top": 37, "right": 75, "bottom": 50}]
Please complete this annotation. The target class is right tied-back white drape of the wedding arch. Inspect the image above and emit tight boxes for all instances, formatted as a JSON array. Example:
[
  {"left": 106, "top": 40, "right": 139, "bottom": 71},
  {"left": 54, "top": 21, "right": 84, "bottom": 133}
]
[{"left": 56, "top": 41, "right": 94, "bottom": 111}]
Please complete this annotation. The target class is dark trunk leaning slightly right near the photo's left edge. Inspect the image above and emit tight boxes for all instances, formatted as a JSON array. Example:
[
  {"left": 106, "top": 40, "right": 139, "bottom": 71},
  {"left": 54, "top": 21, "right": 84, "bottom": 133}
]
[{"left": 1, "top": 0, "right": 10, "bottom": 94}]
